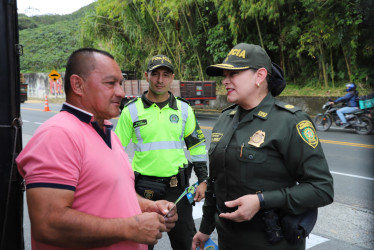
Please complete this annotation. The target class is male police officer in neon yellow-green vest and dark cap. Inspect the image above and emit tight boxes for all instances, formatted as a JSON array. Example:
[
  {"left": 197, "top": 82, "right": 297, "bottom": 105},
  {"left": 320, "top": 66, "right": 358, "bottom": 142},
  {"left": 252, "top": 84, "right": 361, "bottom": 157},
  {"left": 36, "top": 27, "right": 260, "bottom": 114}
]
[{"left": 115, "top": 55, "right": 207, "bottom": 250}]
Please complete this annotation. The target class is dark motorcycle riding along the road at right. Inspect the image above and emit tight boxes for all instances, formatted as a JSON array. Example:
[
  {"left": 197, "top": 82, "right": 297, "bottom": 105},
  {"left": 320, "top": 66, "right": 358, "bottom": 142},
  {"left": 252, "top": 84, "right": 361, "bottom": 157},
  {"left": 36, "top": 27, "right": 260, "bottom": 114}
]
[{"left": 314, "top": 100, "right": 373, "bottom": 135}]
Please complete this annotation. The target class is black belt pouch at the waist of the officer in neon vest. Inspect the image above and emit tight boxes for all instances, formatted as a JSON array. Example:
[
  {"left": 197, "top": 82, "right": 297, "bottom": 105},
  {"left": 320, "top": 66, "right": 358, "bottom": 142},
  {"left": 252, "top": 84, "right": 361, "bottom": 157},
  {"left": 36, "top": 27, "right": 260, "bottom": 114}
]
[{"left": 135, "top": 178, "right": 167, "bottom": 201}]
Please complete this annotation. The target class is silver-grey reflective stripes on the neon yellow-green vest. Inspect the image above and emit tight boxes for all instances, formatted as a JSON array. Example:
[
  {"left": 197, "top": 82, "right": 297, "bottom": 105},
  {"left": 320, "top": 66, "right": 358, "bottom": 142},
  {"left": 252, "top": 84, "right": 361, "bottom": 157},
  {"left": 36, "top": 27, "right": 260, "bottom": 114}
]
[{"left": 127, "top": 101, "right": 188, "bottom": 152}]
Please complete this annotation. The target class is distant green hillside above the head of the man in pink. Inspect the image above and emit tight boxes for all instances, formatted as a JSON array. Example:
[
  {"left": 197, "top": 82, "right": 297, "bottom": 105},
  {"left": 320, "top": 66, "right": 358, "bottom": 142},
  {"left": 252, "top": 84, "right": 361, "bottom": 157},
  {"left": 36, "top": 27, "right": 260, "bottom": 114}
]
[{"left": 18, "top": 3, "right": 94, "bottom": 73}]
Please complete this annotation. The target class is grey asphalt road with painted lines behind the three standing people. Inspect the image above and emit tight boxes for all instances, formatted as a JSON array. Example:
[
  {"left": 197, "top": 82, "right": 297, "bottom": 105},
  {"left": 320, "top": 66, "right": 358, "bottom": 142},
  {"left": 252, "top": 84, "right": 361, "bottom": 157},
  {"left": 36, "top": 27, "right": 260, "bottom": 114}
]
[{"left": 21, "top": 102, "right": 374, "bottom": 250}]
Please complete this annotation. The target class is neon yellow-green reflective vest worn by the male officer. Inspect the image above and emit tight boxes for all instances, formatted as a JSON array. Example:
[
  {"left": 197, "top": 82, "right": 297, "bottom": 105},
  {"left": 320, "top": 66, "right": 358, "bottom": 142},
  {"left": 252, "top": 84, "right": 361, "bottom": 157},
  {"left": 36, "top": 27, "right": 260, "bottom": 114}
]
[{"left": 115, "top": 92, "right": 207, "bottom": 177}]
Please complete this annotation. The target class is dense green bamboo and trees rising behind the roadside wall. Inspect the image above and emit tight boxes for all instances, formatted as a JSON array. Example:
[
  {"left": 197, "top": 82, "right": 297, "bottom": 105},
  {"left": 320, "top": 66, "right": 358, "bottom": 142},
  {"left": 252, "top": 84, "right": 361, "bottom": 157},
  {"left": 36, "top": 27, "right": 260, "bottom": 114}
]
[{"left": 20, "top": 0, "right": 374, "bottom": 90}]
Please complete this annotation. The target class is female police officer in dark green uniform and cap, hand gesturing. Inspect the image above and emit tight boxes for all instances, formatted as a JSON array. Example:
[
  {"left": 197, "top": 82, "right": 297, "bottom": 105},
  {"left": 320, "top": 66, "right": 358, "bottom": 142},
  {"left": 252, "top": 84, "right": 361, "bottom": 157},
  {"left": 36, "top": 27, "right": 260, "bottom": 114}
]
[{"left": 192, "top": 43, "right": 333, "bottom": 250}]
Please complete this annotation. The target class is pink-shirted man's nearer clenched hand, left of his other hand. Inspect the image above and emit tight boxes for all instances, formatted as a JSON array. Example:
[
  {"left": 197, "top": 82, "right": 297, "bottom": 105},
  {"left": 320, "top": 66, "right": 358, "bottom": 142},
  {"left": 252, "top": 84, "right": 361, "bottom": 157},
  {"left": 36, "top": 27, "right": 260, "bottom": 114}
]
[{"left": 130, "top": 213, "right": 166, "bottom": 245}]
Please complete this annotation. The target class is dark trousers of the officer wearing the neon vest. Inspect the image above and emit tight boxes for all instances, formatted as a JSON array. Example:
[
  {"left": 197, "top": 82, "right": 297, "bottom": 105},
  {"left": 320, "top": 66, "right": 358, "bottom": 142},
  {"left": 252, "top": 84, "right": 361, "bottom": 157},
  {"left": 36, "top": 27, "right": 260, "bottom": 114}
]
[{"left": 148, "top": 186, "right": 196, "bottom": 250}]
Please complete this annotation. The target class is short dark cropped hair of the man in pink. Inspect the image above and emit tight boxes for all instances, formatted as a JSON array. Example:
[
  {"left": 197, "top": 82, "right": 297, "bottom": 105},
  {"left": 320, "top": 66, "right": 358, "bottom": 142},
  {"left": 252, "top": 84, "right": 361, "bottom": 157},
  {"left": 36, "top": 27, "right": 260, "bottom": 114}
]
[{"left": 64, "top": 48, "right": 114, "bottom": 95}]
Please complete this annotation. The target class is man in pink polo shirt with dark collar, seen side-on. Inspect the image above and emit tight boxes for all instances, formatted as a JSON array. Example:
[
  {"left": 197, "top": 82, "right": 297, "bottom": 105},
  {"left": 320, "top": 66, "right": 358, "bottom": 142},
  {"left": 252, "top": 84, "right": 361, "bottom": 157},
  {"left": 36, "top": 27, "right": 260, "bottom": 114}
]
[{"left": 16, "top": 48, "right": 178, "bottom": 250}]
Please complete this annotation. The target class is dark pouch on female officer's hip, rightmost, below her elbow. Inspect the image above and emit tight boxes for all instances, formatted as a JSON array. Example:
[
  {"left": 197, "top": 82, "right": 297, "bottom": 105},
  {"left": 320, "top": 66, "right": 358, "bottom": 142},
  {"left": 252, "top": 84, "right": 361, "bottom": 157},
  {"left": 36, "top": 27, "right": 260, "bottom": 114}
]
[{"left": 281, "top": 208, "right": 318, "bottom": 243}]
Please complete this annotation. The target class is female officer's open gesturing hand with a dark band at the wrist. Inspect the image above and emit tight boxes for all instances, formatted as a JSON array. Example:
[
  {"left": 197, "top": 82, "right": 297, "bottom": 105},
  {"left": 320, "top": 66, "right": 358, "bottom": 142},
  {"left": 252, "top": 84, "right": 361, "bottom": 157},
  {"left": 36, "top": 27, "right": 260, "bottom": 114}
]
[{"left": 219, "top": 194, "right": 260, "bottom": 222}]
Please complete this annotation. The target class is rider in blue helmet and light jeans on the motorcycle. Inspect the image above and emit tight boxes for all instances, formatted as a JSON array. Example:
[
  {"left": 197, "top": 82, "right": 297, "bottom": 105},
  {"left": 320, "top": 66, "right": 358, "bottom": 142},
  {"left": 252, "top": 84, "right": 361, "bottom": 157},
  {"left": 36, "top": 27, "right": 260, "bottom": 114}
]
[{"left": 330, "top": 82, "right": 358, "bottom": 128}]
